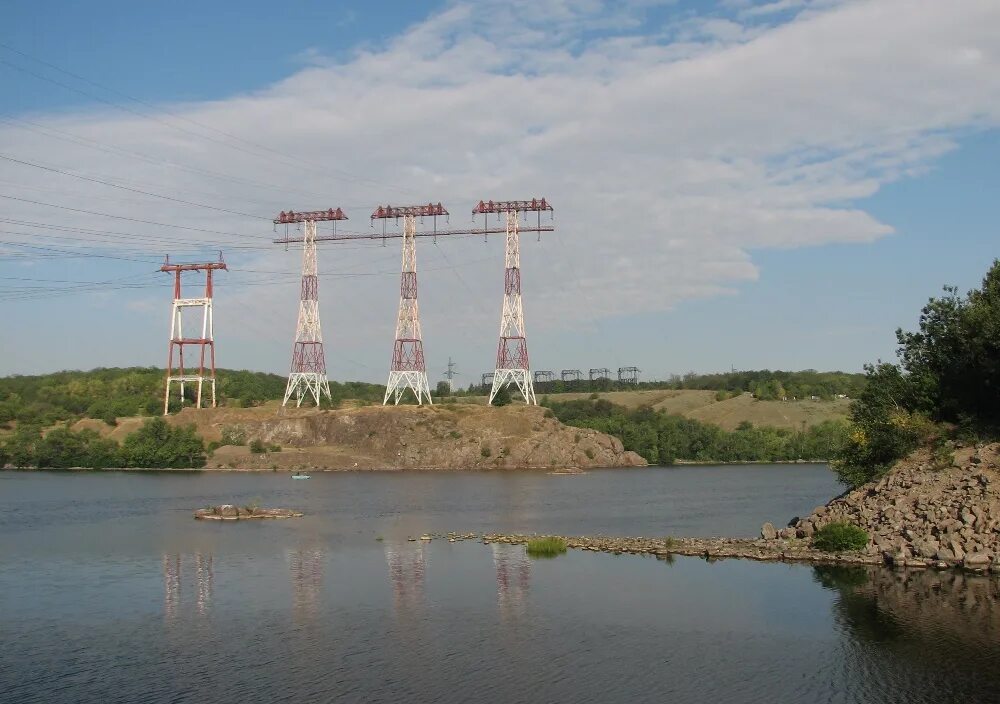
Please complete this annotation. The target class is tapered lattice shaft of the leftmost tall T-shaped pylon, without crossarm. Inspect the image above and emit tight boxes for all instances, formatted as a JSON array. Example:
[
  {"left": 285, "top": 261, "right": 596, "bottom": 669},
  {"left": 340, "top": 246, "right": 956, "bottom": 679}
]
[{"left": 281, "top": 220, "right": 330, "bottom": 406}]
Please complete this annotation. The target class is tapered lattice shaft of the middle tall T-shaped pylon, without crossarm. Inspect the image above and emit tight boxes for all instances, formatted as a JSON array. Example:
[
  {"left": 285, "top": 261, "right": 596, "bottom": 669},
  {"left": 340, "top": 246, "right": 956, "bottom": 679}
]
[{"left": 382, "top": 215, "right": 433, "bottom": 406}]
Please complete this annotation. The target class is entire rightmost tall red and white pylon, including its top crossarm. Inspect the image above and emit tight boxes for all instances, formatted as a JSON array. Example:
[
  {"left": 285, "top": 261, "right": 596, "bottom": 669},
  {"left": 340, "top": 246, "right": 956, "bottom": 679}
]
[{"left": 472, "top": 198, "right": 552, "bottom": 405}]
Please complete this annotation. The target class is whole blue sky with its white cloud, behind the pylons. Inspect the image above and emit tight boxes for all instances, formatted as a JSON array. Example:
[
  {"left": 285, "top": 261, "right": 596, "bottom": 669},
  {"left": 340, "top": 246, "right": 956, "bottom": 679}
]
[{"left": 0, "top": 0, "right": 1000, "bottom": 385}]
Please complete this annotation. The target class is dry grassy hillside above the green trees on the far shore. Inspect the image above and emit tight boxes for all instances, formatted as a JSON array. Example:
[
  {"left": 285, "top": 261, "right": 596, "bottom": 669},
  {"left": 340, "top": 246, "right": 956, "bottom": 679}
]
[{"left": 532, "top": 391, "right": 851, "bottom": 430}]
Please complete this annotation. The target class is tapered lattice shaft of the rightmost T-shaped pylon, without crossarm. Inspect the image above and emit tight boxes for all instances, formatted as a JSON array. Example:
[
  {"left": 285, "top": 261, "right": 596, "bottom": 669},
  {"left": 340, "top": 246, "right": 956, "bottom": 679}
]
[{"left": 489, "top": 210, "right": 538, "bottom": 405}]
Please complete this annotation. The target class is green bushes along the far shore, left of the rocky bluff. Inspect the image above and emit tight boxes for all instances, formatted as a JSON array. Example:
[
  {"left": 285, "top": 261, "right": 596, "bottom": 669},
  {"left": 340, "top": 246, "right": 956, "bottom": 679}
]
[{"left": 0, "top": 418, "right": 206, "bottom": 469}]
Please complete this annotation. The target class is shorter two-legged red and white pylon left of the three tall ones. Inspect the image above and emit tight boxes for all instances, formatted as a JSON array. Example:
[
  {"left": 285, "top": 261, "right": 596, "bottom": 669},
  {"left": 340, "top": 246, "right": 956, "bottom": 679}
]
[{"left": 160, "top": 252, "right": 226, "bottom": 415}]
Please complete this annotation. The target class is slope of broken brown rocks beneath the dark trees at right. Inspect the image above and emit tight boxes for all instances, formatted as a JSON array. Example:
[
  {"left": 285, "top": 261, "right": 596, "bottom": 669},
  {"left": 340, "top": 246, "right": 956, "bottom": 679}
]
[{"left": 761, "top": 444, "right": 1000, "bottom": 572}]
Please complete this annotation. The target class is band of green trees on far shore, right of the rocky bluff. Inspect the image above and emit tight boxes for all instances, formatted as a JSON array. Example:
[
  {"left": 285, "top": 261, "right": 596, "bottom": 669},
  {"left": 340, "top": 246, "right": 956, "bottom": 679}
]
[{"left": 551, "top": 399, "right": 847, "bottom": 464}]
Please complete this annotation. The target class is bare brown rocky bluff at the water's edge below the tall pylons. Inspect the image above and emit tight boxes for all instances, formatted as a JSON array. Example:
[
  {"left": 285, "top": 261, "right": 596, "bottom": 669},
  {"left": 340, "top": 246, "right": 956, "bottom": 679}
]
[{"left": 171, "top": 404, "right": 646, "bottom": 470}]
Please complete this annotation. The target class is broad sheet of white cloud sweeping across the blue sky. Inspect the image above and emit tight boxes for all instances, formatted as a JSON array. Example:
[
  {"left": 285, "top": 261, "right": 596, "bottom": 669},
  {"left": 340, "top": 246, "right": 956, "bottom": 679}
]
[{"left": 0, "top": 0, "right": 1000, "bottom": 376}]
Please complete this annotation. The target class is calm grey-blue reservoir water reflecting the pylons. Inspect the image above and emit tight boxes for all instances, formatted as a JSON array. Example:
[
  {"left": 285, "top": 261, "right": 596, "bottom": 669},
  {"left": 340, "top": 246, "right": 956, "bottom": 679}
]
[{"left": 0, "top": 465, "right": 1000, "bottom": 704}]
